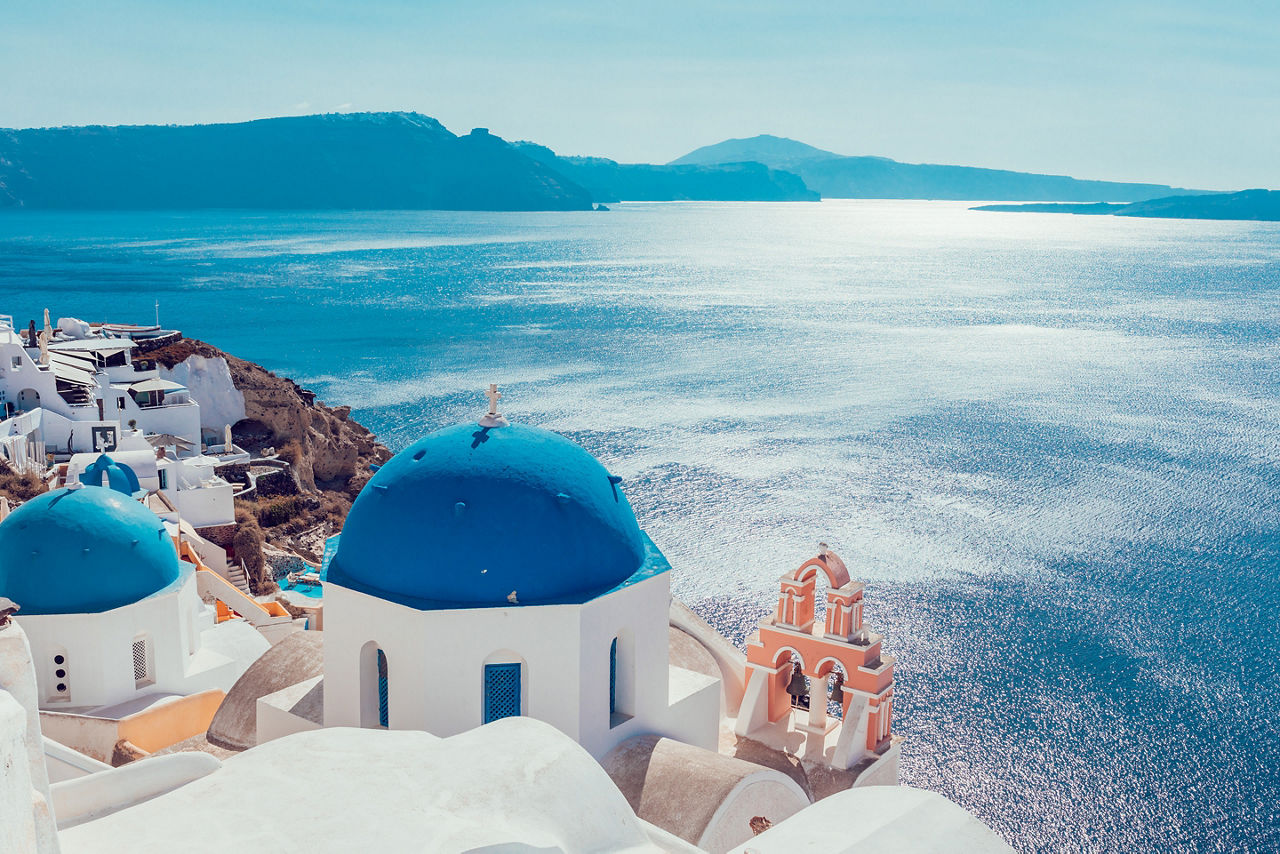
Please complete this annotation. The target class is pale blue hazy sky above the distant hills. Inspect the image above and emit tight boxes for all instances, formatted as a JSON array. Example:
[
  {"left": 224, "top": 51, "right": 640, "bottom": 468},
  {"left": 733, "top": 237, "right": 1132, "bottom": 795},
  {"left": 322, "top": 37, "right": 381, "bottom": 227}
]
[{"left": 0, "top": 0, "right": 1280, "bottom": 189}]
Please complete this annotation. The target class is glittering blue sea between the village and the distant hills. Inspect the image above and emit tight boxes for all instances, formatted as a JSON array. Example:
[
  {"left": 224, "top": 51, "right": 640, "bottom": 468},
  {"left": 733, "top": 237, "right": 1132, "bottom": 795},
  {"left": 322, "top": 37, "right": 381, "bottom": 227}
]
[{"left": 0, "top": 201, "right": 1280, "bottom": 851}]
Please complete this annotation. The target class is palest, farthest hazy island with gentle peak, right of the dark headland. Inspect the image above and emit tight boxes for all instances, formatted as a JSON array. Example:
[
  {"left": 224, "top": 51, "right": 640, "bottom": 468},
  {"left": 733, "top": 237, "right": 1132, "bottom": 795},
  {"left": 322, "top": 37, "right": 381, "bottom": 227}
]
[{"left": 671, "top": 134, "right": 1199, "bottom": 202}]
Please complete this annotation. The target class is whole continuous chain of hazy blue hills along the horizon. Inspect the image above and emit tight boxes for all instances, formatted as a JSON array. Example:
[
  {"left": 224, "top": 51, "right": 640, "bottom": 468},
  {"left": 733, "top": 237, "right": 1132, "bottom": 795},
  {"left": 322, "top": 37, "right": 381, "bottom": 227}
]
[{"left": 0, "top": 113, "right": 1239, "bottom": 209}]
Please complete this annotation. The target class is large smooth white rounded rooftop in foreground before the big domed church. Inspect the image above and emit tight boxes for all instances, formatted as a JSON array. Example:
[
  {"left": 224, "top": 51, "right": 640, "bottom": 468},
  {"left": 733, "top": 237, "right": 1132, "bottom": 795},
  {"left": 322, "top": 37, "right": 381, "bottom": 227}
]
[{"left": 59, "top": 717, "right": 696, "bottom": 854}]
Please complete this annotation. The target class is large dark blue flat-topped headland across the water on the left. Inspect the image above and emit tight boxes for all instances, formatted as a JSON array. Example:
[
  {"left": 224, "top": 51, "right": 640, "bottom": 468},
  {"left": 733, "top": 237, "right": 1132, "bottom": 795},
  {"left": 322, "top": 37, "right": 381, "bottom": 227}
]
[{"left": 0, "top": 113, "right": 591, "bottom": 210}]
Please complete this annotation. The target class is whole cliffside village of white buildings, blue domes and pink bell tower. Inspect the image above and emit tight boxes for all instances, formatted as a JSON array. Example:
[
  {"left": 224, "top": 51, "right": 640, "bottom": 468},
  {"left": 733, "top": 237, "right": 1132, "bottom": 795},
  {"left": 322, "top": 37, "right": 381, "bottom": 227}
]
[{"left": 0, "top": 311, "right": 1010, "bottom": 854}]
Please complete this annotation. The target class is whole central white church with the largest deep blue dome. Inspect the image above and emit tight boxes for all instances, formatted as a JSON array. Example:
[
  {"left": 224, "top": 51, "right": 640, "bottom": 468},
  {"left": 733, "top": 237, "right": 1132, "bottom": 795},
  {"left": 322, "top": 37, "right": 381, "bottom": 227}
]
[{"left": 313, "top": 396, "right": 719, "bottom": 757}]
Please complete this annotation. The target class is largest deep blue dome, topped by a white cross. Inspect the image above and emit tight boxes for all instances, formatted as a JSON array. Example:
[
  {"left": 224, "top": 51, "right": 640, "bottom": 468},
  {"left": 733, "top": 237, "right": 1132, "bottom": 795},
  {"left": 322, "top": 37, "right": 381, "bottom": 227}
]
[{"left": 328, "top": 424, "right": 645, "bottom": 608}]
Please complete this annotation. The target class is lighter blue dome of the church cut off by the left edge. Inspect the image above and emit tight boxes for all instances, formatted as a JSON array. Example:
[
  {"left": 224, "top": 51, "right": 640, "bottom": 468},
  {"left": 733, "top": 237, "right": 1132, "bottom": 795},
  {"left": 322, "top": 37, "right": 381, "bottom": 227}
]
[{"left": 0, "top": 487, "right": 182, "bottom": 616}]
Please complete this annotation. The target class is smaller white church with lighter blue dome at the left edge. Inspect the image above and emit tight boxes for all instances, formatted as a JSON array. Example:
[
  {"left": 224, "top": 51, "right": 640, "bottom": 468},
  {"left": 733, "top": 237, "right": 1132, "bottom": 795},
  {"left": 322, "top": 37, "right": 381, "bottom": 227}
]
[{"left": 0, "top": 478, "right": 270, "bottom": 711}]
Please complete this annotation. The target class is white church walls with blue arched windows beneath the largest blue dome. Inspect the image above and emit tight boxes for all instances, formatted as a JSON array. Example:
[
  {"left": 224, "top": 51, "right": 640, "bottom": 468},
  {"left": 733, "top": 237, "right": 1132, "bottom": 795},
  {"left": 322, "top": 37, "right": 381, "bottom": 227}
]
[{"left": 324, "top": 574, "right": 719, "bottom": 757}]
